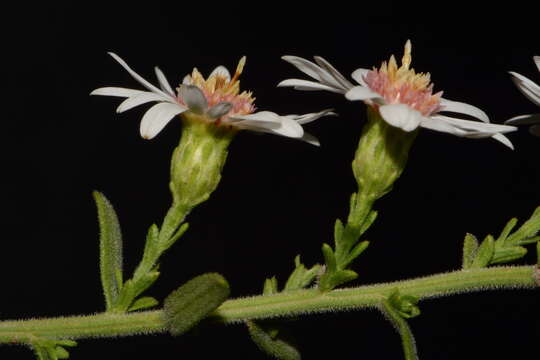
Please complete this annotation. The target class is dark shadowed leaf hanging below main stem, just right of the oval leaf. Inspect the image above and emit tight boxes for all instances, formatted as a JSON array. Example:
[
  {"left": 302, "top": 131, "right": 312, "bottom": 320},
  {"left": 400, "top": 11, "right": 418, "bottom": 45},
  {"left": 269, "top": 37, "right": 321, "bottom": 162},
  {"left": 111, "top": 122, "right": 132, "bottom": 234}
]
[{"left": 246, "top": 321, "right": 302, "bottom": 360}]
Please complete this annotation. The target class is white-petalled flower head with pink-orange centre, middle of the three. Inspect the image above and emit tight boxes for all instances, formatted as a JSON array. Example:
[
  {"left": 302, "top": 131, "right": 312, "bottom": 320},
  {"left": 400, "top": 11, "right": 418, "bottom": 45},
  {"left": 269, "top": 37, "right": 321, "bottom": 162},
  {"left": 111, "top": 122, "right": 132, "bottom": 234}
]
[{"left": 278, "top": 41, "right": 517, "bottom": 149}]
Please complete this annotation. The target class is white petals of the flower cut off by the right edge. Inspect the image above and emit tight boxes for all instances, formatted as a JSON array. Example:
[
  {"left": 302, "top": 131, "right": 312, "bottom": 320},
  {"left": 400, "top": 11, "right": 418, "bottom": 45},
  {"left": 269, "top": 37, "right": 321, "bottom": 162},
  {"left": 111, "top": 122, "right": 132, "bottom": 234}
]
[{"left": 505, "top": 56, "right": 540, "bottom": 136}]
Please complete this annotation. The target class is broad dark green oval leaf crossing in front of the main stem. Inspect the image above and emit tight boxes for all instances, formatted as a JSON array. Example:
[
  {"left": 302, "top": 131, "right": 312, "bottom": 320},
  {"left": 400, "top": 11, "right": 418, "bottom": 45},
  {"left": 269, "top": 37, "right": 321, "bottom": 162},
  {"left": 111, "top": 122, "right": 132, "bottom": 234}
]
[{"left": 163, "top": 273, "right": 230, "bottom": 336}]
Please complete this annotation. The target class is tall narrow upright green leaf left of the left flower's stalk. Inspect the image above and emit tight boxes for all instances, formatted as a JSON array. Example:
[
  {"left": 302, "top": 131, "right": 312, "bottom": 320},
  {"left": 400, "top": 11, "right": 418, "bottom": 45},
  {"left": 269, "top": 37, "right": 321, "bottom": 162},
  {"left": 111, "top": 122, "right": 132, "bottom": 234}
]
[{"left": 93, "top": 191, "right": 123, "bottom": 310}]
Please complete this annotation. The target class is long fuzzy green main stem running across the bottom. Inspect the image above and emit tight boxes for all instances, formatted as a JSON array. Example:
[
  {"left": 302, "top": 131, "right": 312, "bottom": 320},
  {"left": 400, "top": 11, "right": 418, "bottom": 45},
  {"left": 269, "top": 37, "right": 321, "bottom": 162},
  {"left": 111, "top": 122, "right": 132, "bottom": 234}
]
[{"left": 0, "top": 266, "right": 538, "bottom": 344}]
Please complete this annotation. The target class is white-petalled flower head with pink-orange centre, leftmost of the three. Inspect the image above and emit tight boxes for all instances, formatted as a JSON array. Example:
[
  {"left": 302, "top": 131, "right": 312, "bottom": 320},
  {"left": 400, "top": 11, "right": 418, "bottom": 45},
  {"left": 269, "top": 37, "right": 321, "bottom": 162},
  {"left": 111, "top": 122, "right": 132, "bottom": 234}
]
[{"left": 90, "top": 53, "right": 335, "bottom": 145}]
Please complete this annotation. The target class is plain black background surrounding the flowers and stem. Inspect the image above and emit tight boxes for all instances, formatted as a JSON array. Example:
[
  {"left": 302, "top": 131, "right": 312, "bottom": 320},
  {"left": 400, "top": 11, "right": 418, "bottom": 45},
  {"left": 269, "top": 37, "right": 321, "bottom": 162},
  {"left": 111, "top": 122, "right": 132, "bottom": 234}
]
[{"left": 4, "top": 2, "right": 540, "bottom": 359}]
